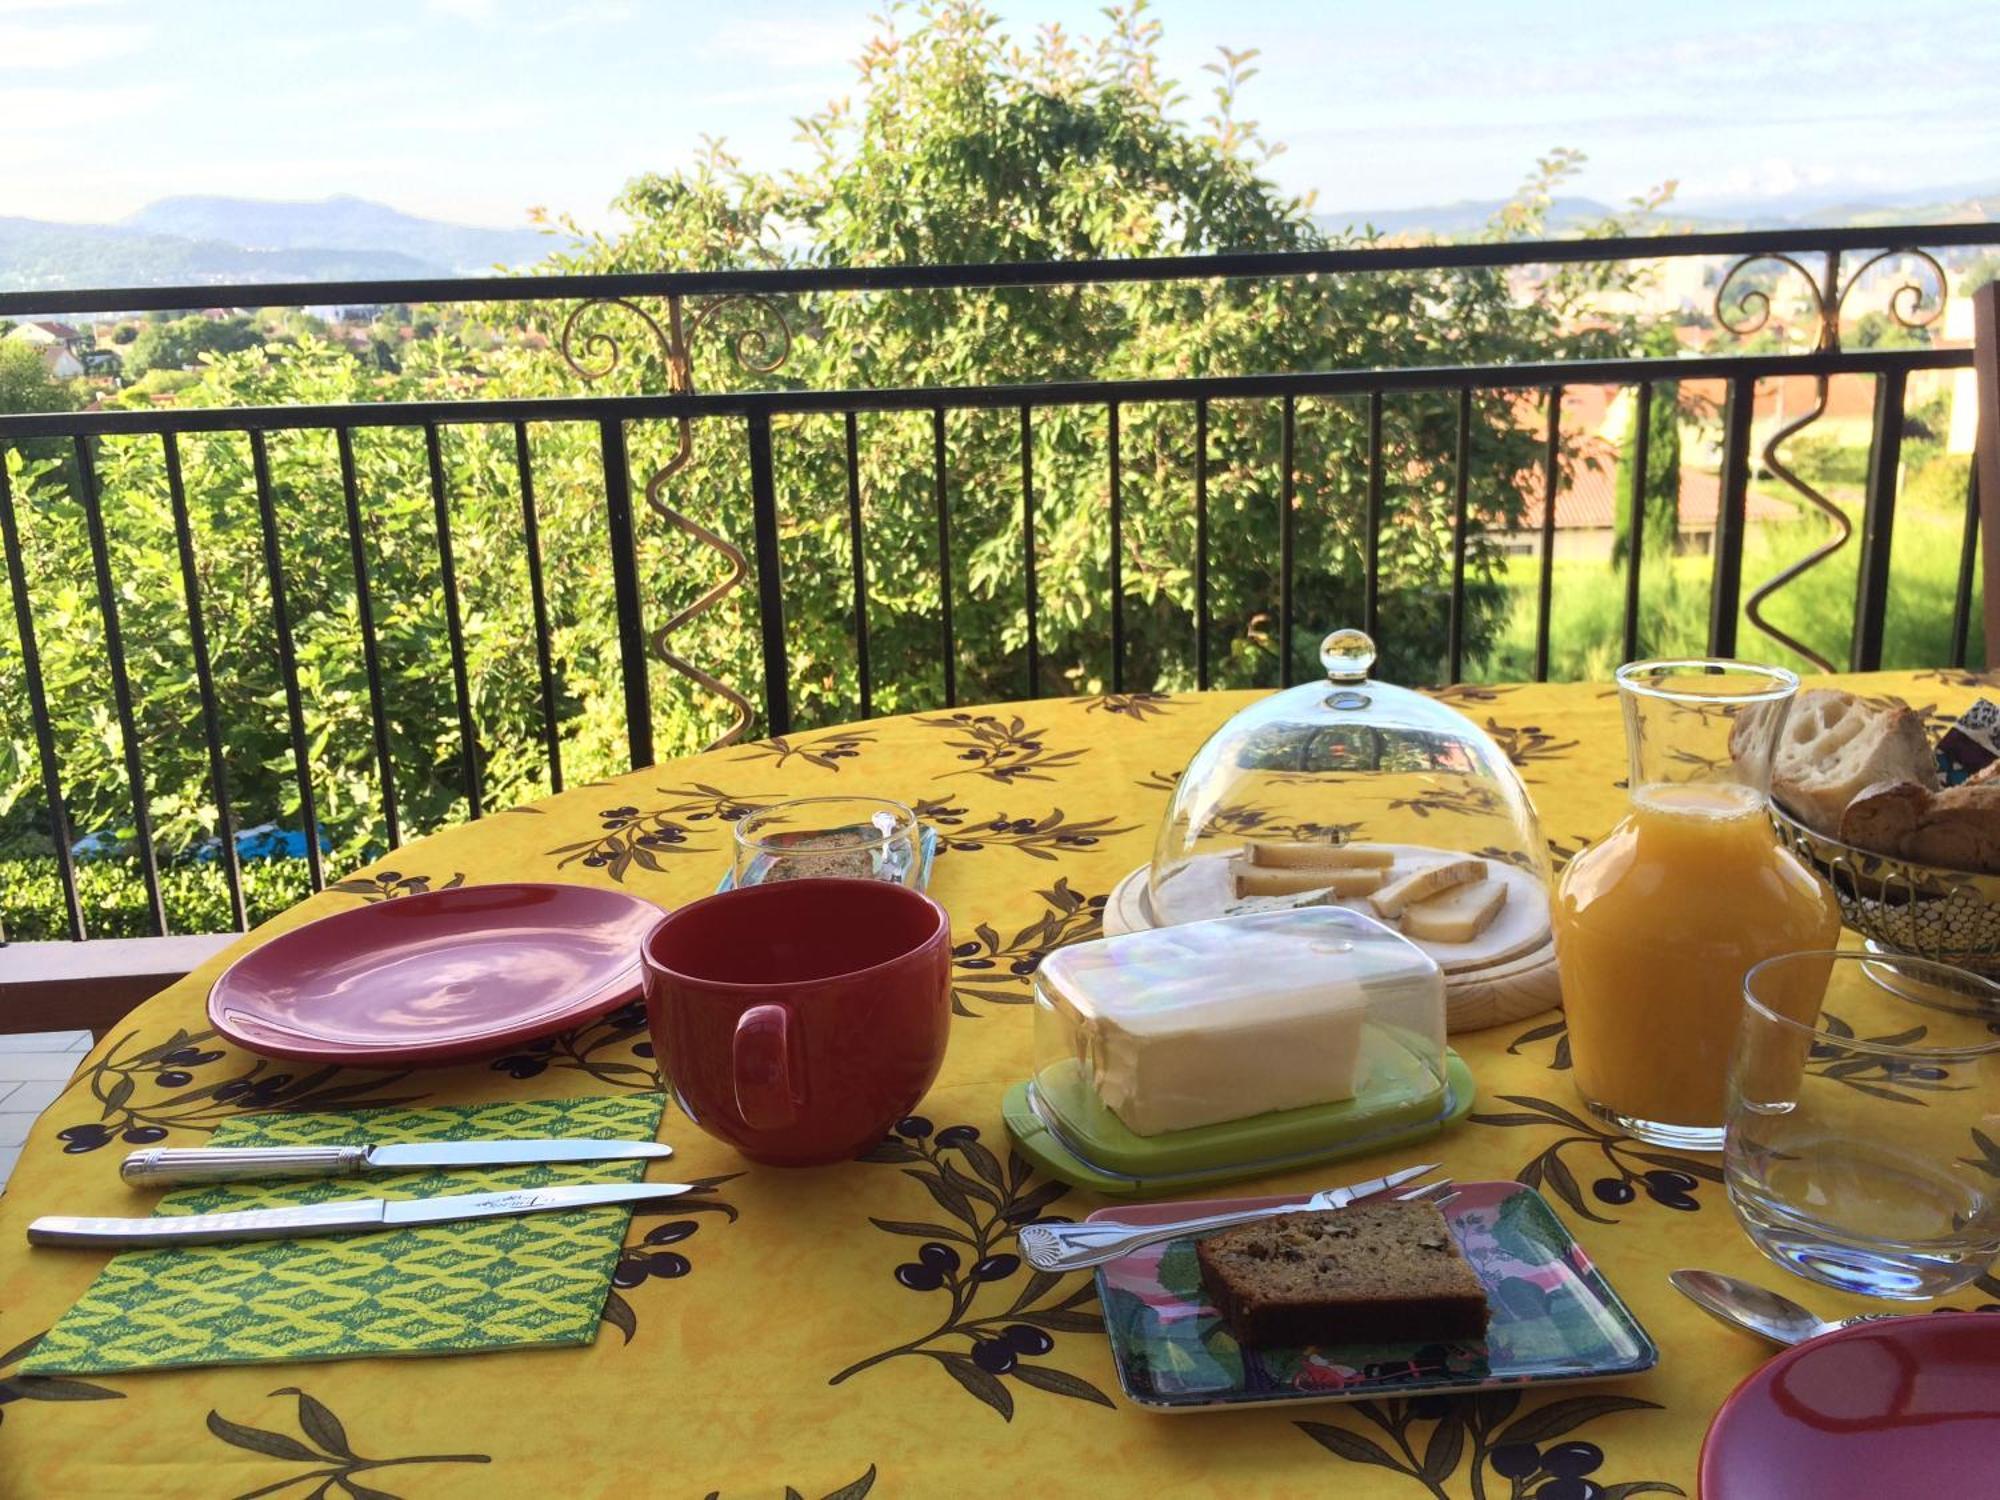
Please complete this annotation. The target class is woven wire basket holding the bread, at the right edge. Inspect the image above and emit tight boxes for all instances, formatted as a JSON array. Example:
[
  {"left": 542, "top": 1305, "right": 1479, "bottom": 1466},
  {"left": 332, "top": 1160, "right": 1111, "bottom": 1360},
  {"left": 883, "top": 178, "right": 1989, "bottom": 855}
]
[{"left": 1770, "top": 800, "right": 2000, "bottom": 976}]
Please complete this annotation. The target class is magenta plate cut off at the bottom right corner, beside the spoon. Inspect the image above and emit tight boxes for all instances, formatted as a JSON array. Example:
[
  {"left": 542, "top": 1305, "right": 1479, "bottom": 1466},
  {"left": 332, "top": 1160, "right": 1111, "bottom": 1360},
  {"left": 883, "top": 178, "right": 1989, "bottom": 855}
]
[{"left": 1702, "top": 1312, "right": 2000, "bottom": 1500}]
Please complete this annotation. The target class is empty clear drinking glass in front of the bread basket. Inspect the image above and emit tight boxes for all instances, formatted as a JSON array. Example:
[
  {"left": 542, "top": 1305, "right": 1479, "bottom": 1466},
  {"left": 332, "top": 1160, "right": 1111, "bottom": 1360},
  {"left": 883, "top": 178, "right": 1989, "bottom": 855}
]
[{"left": 1724, "top": 952, "right": 2000, "bottom": 1298}]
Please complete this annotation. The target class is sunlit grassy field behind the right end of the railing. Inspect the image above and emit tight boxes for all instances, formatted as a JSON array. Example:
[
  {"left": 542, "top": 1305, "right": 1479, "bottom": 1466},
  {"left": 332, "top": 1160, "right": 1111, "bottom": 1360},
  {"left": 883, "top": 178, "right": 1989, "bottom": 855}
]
[{"left": 1470, "top": 484, "right": 1986, "bottom": 682}]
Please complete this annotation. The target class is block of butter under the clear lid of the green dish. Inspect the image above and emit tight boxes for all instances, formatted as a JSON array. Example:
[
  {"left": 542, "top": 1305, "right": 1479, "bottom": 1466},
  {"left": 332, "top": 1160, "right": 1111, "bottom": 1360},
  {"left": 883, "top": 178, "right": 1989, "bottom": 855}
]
[{"left": 1036, "top": 906, "right": 1444, "bottom": 1136}]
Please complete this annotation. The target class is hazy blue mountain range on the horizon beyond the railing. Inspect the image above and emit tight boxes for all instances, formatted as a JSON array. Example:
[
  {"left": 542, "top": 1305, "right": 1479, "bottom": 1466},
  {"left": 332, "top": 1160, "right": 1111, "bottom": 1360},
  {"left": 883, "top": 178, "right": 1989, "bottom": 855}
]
[{"left": 0, "top": 178, "right": 2000, "bottom": 292}]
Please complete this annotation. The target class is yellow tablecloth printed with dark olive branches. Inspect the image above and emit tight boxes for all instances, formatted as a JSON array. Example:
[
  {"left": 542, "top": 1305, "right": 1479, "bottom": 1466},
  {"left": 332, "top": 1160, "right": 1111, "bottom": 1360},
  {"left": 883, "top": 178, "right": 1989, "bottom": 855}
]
[{"left": 0, "top": 672, "right": 2000, "bottom": 1500}]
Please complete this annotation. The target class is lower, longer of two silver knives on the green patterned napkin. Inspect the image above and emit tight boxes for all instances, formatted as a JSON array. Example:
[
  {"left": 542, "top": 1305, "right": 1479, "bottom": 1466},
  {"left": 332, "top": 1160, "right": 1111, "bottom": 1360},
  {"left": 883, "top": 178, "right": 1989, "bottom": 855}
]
[{"left": 28, "top": 1182, "right": 694, "bottom": 1248}]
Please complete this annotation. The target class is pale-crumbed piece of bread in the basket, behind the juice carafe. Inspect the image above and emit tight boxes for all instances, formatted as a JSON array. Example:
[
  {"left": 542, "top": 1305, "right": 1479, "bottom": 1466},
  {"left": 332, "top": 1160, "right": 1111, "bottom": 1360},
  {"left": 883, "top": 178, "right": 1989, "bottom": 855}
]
[{"left": 1730, "top": 688, "right": 1938, "bottom": 838}]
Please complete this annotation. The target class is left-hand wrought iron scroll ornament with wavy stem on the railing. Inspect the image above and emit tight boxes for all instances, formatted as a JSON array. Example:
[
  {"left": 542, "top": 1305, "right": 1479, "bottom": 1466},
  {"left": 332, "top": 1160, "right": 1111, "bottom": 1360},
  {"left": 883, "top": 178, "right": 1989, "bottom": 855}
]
[{"left": 556, "top": 294, "right": 792, "bottom": 750}]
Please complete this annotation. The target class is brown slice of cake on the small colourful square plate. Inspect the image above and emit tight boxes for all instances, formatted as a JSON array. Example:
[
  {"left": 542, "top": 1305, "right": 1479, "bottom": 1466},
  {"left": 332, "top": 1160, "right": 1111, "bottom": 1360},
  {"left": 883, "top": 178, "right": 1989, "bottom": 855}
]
[{"left": 1194, "top": 1202, "right": 1488, "bottom": 1346}]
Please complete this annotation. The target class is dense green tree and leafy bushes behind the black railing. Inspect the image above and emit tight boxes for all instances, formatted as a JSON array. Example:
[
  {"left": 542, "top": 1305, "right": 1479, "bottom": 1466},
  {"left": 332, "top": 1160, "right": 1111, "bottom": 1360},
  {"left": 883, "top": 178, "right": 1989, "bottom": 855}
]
[{"left": 0, "top": 2, "right": 1656, "bottom": 930}]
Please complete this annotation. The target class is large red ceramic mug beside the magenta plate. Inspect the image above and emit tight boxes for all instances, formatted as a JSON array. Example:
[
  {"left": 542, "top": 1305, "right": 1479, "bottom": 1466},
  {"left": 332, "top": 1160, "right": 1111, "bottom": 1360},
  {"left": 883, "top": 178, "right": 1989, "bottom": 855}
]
[{"left": 642, "top": 880, "right": 952, "bottom": 1166}]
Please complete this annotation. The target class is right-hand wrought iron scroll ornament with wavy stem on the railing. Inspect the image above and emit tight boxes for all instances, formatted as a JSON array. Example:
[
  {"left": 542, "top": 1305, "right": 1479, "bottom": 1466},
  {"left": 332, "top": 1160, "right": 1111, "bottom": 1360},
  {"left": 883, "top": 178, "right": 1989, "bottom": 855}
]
[{"left": 1716, "top": 246, "right": 1950, "bottom": 672}]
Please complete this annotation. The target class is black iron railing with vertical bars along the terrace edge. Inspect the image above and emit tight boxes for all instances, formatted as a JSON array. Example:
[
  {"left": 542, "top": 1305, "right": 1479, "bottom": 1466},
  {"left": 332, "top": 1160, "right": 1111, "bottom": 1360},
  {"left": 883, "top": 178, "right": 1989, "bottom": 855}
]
[{"left": 0, "top": 226, "right": 2000, "bottom": 938}]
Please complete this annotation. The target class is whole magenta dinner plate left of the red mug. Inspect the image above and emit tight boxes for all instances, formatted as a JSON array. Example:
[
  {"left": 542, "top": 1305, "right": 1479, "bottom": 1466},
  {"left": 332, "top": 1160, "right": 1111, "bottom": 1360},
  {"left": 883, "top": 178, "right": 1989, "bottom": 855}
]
[{"left": 208, "top": 884, "right": 662, "bottom": 1068}]
